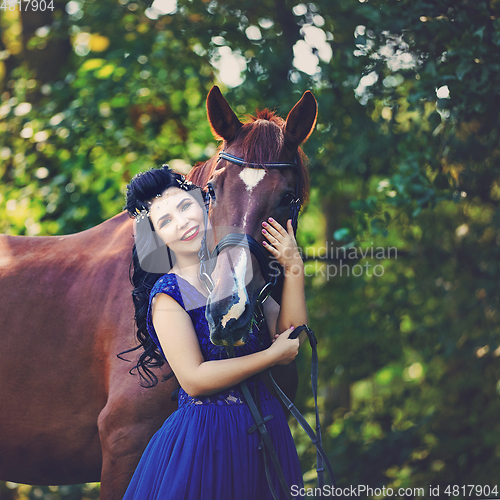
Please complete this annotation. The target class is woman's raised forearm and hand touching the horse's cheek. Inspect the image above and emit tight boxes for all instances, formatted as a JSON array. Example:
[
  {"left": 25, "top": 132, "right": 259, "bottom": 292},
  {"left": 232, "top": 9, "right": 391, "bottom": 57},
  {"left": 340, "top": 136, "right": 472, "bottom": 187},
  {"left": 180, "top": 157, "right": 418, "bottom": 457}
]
[{"left": 262, "top": 218, "right": 307, "bottom": 344}]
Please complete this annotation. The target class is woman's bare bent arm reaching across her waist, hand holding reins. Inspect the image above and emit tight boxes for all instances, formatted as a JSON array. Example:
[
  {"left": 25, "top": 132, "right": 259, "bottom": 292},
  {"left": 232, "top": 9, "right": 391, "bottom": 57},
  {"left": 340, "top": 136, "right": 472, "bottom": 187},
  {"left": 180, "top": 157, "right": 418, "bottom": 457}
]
[{"left": 153, "top": 294, "right": 299, "bottom": 397}]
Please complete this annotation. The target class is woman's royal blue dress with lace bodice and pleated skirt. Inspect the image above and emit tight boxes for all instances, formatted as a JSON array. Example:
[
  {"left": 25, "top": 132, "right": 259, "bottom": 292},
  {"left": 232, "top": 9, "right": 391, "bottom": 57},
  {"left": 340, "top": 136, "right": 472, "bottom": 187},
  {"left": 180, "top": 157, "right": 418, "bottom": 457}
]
[{"left": 123, "top": 274, "right": 303, "bottom": 500}]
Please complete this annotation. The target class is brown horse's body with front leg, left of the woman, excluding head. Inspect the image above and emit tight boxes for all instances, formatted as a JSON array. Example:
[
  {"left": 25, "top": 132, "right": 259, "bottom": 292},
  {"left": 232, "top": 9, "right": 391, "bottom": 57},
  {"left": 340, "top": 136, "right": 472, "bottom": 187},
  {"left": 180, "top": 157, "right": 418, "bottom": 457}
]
[{"left": 0, "top": 213, "right": 176, "bottom": 499}]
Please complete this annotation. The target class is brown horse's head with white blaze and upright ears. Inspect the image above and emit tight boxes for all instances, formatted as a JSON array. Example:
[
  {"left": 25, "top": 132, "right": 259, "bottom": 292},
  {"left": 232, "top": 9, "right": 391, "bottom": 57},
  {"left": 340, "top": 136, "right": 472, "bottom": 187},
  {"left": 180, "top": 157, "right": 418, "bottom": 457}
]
[{"left": 191, "top": 87, "right": 317, "bottom": 345}]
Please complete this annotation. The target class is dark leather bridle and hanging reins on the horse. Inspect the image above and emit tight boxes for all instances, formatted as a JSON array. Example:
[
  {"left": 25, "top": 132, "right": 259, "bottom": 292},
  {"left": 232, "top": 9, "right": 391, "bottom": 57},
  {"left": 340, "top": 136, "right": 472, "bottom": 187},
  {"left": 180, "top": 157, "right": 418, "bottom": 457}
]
[{"left": 199, "top": 151, "right": 335, "bottom": 500}]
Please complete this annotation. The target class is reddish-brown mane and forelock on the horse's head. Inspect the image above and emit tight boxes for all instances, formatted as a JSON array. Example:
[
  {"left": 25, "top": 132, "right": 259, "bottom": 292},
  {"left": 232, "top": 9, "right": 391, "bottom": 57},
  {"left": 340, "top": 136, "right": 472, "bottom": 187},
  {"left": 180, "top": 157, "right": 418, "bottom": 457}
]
[{"left": 187, "top": 109, "right": 310, "bottom": 206}]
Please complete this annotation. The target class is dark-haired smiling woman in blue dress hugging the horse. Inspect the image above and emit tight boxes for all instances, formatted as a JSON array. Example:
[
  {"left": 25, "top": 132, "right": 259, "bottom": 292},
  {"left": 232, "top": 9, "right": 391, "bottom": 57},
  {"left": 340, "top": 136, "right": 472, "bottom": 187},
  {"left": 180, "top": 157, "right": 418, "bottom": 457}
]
[{"left": 124, "top": 166, "right": 307, "bottom": 500}]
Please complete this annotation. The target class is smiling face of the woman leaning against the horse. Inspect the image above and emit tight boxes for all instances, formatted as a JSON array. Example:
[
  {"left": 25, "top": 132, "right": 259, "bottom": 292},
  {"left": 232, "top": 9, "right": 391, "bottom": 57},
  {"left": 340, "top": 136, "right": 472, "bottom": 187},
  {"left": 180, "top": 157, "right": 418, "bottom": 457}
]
[{"left": 149, "top": 187, "right": 205, "bottom": 255}]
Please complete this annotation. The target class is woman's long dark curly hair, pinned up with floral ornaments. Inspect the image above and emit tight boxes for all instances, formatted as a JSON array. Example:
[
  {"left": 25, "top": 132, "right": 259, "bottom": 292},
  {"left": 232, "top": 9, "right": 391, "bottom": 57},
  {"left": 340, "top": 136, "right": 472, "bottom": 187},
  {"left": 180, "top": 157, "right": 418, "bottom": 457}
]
[{"left": 118, "top": 165, "right": 203, "bottom": 387}]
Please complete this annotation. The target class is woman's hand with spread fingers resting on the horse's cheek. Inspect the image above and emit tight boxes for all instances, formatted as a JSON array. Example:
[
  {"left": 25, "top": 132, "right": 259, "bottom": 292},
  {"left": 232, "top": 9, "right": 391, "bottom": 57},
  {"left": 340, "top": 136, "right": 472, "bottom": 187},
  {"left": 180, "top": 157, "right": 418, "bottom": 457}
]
[{"left": 262, "top": 217, "right": 304, "bottom": 275}]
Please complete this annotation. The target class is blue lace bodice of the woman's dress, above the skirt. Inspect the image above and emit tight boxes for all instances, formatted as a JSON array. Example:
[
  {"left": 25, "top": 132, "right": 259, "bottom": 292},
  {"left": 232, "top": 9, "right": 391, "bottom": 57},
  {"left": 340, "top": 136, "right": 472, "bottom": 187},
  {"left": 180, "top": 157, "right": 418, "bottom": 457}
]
[{"left": 146, "top": 273, "right": 271, "bottom": 406}]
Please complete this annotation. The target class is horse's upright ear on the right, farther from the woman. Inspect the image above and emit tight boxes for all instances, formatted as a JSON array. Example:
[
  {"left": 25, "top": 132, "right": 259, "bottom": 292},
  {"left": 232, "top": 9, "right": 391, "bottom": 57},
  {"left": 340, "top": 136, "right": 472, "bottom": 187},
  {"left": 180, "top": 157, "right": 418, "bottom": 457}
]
[{"left": 285, "top": 90, "right": 318, "bottom": 149}]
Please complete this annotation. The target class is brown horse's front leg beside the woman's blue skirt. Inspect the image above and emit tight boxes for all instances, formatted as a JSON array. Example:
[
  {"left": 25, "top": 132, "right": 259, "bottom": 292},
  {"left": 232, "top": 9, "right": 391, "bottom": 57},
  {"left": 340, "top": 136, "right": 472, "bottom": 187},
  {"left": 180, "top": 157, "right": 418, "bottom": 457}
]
[{"left": 98, "top": 367, "right": 177, "bottom": 500}]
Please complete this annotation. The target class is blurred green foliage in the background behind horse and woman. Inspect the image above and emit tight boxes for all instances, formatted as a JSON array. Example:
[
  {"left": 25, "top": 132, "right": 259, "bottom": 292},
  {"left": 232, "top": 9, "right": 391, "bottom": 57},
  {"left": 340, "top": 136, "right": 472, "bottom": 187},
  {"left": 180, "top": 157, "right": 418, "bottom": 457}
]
[{"left": 0, "top": 0, "right": 500, "bottom": 498}]
